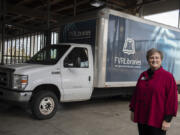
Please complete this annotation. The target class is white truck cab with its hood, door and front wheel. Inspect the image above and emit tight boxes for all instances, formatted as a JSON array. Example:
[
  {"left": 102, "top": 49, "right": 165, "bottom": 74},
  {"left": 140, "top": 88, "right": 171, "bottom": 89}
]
[{"left": 0, "top": 43, "right": 93, "bottom": 119}]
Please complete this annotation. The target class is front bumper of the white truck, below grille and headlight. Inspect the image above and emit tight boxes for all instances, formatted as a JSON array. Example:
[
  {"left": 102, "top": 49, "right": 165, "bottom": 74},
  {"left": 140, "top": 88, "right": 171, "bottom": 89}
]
[{"left": 0, "top": 88, "right": 32, "bottom": 102}]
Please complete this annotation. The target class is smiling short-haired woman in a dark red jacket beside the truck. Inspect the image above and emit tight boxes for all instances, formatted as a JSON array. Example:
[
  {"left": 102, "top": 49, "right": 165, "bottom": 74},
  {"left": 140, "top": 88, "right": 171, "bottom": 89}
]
[{"left": 130, "top": 48, "right": 178, "bottom": 135}]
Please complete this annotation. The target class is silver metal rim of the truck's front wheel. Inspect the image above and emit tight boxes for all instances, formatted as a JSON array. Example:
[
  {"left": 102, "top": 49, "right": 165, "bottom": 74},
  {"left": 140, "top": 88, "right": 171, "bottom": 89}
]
[{"left": 39, "top": 97, "right": 55, "bottom": 115}]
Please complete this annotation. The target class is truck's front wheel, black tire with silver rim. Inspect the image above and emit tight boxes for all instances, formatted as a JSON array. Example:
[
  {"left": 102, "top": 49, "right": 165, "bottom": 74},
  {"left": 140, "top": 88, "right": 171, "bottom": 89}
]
[{"left": 31, "top": 91, "right": 58, "bottom": 120}]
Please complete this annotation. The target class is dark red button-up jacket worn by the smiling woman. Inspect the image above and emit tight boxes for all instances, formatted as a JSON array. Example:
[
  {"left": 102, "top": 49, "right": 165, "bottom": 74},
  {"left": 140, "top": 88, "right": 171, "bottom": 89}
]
[{"left": 130, "top": 67, "right": 178, "bottom": 128}]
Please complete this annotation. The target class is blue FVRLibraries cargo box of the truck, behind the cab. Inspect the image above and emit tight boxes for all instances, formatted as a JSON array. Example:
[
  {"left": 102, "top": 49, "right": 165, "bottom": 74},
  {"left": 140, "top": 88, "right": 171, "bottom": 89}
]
[{"left": 60, "top": 8, "right": 180, "bottom": 88}]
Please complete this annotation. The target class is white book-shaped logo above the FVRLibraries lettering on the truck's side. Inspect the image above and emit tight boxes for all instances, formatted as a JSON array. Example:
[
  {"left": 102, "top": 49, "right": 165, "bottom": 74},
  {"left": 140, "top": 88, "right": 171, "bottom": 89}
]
[{"left": 123, "top": 38, "right": 135, "bottom": 55}]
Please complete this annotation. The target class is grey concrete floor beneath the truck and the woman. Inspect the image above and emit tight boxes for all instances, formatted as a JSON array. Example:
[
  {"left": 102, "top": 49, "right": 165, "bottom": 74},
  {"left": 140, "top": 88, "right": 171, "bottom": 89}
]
[{"left": 0, "top": 97, "right": 180, "bottom": 135}]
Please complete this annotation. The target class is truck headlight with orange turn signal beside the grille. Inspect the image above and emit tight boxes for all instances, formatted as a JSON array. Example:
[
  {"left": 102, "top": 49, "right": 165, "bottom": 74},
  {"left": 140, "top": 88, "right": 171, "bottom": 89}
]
[{"left": 13, "top": 74, "right": 28, "bottom": 90}]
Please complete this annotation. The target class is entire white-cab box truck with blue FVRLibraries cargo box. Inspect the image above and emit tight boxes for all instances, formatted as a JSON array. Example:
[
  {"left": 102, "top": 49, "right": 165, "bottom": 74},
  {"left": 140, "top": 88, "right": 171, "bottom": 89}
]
[{"left": 0, "top": 8, "right": 180, "bottom": 119}]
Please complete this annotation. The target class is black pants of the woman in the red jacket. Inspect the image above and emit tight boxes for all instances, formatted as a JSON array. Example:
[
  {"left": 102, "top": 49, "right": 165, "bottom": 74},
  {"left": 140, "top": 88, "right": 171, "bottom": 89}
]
[{"left": 138, "top": 123, "right": 166, "bottom": 135}]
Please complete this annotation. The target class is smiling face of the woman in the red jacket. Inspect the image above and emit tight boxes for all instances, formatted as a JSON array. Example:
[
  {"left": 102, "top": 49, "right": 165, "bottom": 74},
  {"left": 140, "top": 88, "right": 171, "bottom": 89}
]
[{"left": 148, "top": 52, "right": 162, "bottom": 70}]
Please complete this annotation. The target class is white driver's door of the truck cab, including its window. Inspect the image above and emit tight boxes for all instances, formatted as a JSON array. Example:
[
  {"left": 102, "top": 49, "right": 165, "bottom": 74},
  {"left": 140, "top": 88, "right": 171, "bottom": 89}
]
[{"left": 61, "top": 47, "right": 93, "bottom": 101}]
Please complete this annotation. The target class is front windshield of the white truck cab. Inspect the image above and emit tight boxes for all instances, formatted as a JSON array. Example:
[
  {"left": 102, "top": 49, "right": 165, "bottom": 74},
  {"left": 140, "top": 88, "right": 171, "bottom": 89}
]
[{"left": 27, "top": 45, "right": 70, "bottom": 65}]
